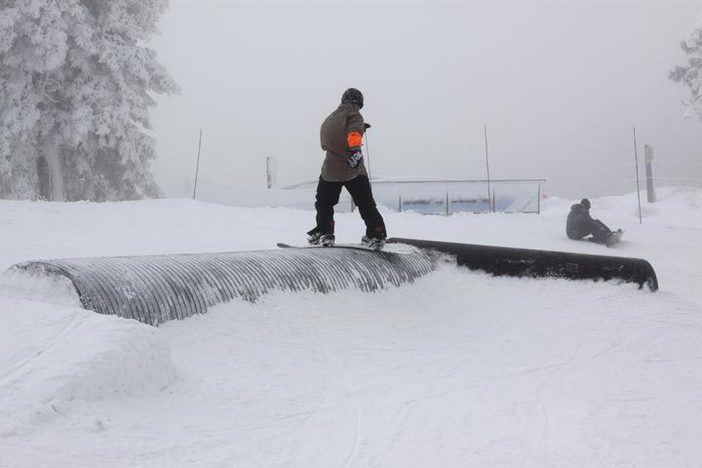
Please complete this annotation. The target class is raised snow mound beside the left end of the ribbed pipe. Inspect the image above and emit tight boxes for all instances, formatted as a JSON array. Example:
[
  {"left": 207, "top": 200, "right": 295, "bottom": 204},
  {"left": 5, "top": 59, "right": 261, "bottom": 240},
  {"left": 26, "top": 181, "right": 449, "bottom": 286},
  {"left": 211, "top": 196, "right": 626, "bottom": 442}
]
[{"left": 0, "top": 299, "right": 176, "bottom": 436}]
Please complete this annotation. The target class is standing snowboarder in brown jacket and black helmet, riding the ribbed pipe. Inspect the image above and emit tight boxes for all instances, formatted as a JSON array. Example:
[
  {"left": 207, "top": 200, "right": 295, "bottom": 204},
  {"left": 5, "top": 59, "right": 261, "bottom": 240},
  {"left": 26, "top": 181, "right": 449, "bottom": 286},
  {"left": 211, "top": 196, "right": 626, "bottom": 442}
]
[{"left": 307, "top": 88, "right": 387, "bottom": 248}]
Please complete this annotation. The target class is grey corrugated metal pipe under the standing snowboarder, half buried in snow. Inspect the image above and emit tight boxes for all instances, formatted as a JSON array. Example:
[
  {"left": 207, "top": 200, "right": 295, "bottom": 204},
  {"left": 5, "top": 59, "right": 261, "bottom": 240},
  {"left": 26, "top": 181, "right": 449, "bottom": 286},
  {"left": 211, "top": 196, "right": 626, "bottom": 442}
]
[{"left": 12, "top": 248, "right": 433, "bottom": 325}]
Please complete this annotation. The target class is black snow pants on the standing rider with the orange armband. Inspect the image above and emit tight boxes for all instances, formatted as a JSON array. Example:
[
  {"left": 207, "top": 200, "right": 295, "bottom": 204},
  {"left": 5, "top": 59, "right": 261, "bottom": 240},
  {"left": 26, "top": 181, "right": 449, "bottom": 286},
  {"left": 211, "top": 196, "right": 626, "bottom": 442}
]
[{"left": 314, "top": 175, "right": 387, "bottom": 239}]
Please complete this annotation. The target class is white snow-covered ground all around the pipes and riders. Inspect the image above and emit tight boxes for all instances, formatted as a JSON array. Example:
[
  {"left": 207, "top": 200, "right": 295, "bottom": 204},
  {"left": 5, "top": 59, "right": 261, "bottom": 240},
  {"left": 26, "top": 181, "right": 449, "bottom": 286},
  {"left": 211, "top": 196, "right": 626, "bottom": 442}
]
[{"left": 0, "top": 189, "right": 702, "bottom": 467}]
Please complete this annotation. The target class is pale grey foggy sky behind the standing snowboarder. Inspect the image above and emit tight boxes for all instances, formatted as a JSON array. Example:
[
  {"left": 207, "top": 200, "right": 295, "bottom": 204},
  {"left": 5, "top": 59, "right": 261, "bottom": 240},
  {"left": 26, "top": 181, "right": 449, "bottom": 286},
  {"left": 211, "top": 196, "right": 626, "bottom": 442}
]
[{"left": 151, "top": 0, "right": 702, "bottom": 198}]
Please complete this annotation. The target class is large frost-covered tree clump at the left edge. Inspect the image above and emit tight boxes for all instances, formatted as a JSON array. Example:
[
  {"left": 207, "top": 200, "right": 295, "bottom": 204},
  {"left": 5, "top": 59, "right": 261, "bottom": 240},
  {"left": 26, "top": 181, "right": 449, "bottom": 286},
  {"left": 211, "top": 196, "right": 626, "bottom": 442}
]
[{"left": 0, "top": 0, "right": 178, "bottom": 200}]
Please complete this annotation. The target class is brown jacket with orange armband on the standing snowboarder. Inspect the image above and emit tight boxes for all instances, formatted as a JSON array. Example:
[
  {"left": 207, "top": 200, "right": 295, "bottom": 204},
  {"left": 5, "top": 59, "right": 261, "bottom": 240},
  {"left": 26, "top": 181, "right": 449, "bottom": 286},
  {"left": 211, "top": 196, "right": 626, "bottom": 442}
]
[{"left": 319, "top": 104, "right": 368, "bottom": 182}]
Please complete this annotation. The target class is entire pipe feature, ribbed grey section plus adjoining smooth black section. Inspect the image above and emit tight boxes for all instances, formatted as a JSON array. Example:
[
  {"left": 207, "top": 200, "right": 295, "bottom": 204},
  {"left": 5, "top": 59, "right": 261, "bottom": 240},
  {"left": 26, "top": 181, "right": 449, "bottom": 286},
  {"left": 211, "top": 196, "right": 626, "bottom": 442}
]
[{"left": 10, "top": 238, "right": 658, "bottom": 325}]
